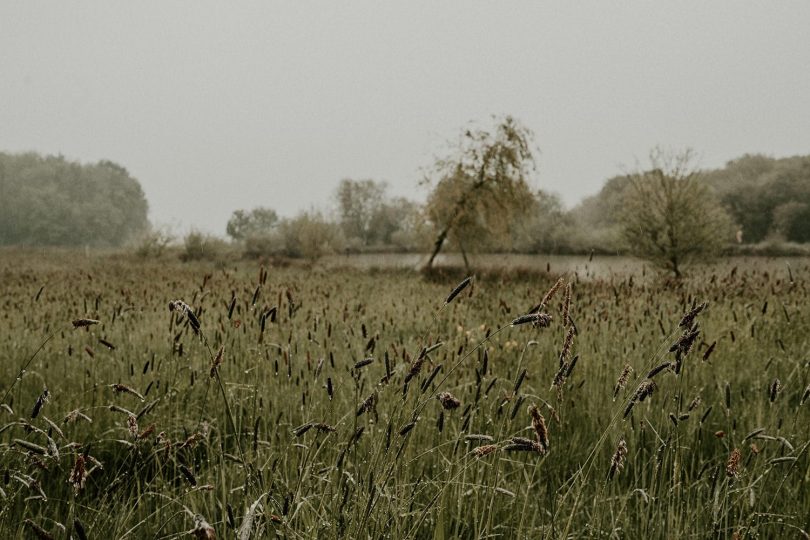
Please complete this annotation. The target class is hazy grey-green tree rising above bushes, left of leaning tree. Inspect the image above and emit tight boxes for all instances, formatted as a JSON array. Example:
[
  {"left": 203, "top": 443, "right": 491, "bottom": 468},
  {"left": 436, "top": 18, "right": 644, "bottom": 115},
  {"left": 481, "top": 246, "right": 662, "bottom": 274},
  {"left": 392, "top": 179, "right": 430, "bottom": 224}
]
[{"left": 337, "top": 178, "right": 387, "bottom": 246}]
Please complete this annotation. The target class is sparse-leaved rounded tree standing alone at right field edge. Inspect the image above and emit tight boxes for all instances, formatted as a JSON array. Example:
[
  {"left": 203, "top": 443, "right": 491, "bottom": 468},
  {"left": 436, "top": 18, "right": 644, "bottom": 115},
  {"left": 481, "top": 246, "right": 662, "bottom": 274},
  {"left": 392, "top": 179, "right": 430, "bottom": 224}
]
[{"left": 620, "top": 150, "right": 731, "bottom": 277}]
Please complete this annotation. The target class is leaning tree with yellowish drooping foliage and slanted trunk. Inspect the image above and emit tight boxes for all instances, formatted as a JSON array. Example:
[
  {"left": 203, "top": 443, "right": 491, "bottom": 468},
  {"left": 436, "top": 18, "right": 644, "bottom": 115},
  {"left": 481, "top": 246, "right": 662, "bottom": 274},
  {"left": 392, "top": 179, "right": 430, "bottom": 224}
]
[{"left": 426, "top": 116, "right": 534, "bottom": 269}]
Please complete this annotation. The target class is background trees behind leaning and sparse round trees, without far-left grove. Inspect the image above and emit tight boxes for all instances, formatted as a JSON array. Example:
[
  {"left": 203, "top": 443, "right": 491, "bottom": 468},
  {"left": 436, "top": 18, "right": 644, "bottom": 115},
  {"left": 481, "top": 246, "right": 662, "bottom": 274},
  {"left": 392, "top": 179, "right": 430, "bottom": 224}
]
[{"left": 219, "top": 155, "right": 810, "bottom": 256}]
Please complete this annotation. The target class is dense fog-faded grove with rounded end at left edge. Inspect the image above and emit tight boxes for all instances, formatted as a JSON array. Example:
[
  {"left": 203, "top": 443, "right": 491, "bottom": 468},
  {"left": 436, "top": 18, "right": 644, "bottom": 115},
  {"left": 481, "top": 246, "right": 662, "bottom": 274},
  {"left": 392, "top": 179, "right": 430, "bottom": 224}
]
[{"left": 0, "top": 153, "right": 149, "bottom": 246}]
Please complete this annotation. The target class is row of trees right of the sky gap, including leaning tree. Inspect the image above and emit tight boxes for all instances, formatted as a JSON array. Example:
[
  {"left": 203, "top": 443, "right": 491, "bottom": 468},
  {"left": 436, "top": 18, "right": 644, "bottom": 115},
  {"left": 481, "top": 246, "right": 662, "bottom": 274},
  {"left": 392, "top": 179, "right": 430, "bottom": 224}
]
[{"left": 221, "top": 117, "right": 810, "bottom": 275}]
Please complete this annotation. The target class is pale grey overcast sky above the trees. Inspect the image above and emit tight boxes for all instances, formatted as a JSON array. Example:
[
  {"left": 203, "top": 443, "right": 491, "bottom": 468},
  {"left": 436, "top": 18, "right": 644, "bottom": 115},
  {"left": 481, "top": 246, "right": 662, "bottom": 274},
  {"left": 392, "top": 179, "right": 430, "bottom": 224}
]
[{"left": 0, "top": 0, "right": 810, "bottom": 234}]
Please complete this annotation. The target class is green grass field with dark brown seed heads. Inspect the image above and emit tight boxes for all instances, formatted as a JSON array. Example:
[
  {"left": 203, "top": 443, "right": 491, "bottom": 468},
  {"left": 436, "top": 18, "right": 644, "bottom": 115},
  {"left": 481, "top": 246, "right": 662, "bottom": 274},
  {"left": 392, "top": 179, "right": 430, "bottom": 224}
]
[{"left": 0, "top": 251, "right": 810, "bottom": 539}]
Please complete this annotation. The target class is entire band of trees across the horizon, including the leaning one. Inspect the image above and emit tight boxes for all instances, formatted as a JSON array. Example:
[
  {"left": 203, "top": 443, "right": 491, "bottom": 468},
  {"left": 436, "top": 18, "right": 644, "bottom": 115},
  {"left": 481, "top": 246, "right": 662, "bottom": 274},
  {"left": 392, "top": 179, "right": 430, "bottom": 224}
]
[{"left": 0, "top": 117, "right": 810, "bottom": 275}]
